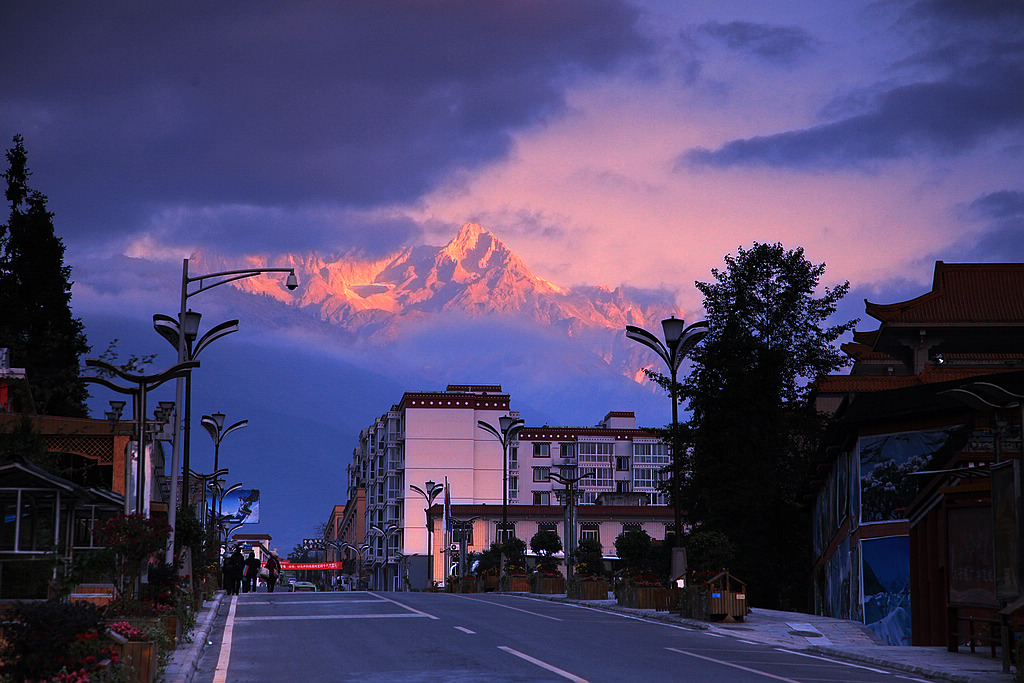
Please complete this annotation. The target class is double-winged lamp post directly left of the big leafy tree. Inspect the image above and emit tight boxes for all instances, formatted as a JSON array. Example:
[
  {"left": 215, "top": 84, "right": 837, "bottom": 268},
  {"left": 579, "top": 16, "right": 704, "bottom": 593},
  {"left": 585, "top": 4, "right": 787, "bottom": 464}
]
[{"left": 626, "top": 315, "right": 711, "bottom": 548}]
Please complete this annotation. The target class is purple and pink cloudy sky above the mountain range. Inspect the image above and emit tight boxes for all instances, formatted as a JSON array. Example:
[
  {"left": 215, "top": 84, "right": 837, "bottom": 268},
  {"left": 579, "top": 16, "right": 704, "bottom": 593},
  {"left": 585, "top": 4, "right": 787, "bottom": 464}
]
[{"left": 0, "top": 0, "right": 1024, "bottom": 545}]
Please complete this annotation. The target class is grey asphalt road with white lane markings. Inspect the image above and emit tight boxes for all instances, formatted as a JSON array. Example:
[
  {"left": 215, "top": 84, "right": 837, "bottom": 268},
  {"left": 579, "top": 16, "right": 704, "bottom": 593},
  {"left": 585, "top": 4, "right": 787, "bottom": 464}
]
[{"left": 194, "top": 592, "right": 937, "bottom": 683}]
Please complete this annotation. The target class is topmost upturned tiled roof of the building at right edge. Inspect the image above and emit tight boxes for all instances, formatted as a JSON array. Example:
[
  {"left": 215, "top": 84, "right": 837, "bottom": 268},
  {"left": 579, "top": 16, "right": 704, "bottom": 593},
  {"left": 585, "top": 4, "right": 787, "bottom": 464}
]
[{"left": 858, "top": 261, "right": 1024, "bottom": 325}]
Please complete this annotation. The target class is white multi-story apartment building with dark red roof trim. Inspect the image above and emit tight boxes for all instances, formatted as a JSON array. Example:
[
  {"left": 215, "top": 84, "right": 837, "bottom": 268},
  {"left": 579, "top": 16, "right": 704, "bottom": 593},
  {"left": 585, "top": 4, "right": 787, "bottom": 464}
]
[{"left": 348, "top": 385, "right": 669, "bottom": 589}]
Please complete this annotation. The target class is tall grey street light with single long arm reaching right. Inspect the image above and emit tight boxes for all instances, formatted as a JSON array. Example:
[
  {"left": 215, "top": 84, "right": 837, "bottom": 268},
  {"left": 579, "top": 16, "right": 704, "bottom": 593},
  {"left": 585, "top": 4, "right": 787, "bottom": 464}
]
[{"left": 165, "top": 259, "right": 299, "bottom": 563}]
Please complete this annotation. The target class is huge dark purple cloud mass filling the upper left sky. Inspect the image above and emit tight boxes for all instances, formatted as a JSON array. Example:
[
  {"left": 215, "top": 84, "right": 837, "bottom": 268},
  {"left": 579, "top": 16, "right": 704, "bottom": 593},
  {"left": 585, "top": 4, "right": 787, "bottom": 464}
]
[{"left": 0, "top": 0, "right": 647, "bottom": 250}]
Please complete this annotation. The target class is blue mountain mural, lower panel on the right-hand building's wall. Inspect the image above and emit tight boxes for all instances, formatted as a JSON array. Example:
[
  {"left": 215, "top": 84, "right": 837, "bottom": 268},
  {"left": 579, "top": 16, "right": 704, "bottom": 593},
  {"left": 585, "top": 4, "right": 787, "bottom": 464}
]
[{"left": 860, "top": 536, "right": 910, "bottom": 645}]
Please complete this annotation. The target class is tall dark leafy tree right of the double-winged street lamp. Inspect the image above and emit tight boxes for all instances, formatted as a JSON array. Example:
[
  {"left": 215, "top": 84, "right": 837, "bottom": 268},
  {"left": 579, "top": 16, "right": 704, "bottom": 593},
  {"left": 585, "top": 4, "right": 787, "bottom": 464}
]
[{"left": 682, "top": 243, "right": 856, "bottom": 607}]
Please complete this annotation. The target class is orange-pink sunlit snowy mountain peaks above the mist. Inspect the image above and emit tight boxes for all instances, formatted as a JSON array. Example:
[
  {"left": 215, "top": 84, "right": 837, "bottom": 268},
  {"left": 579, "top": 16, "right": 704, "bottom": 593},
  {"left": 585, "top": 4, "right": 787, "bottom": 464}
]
[{"left": 201, "top": 223, "right": 680, "bottom": 344}]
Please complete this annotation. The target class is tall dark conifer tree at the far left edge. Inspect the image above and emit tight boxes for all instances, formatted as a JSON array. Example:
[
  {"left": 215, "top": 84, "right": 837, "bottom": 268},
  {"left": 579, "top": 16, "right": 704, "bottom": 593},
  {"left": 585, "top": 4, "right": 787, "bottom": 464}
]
[{"left": 0, "top": 135, "right": 89, "bottom": 417}]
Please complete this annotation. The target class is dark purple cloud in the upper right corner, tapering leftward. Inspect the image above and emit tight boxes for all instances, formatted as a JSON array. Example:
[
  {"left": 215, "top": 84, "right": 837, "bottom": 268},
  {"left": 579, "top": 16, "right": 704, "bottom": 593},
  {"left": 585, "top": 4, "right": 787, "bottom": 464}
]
[{"left": 676, "top": 0, "right": 1024, "bottom": 169}]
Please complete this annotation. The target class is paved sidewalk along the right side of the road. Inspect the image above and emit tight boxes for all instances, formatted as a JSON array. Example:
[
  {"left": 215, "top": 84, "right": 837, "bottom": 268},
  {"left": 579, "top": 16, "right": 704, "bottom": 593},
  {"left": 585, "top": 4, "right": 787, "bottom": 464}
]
[{"left": 524, "top": 594, "right": 1014, "bottom": 683}]
